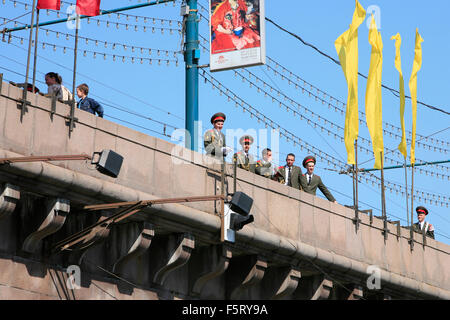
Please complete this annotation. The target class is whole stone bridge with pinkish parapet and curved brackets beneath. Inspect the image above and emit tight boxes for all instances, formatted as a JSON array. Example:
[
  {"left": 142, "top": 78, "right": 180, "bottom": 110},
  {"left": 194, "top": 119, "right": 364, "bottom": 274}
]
[{"left": 0, "top": 82, "right": 450, "bottom": 299}]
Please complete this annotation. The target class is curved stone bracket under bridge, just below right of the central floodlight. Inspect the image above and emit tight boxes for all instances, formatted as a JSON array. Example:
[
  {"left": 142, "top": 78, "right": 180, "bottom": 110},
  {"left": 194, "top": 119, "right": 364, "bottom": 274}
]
[{"left": 226, "top": 255, "right": 267, "bottom": 300}]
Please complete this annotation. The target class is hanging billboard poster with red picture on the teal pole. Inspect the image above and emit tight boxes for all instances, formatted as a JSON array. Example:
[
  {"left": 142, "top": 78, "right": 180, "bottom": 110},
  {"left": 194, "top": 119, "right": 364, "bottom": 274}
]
[{"left": 209, "top": 0, "right": 266, "bottom": 71}]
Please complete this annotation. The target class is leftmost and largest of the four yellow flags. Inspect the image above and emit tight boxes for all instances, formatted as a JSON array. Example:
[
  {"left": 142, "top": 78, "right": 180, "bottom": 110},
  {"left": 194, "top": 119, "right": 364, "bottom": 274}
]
[{"left": 334, "top": 0, "right": 366, "bottom": 164}]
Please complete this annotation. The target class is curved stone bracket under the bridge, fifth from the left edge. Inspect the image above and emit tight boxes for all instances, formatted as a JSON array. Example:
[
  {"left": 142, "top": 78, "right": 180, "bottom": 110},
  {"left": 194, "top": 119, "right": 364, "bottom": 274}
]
[{"left": 153, "top": 233, "right": 195, "bottom": 285}]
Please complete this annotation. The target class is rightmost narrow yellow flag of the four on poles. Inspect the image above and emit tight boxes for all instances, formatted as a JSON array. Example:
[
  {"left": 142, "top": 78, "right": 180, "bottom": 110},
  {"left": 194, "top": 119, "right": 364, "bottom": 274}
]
[{"left": 409, "top": 29, "right": 423, "bottom": 164}]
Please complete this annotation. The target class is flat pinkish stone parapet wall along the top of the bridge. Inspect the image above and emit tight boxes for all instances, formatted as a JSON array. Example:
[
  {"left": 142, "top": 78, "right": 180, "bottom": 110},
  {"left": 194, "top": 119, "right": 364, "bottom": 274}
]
[{"left": 0, "top": 83, "right": 450, "bottom": 298}]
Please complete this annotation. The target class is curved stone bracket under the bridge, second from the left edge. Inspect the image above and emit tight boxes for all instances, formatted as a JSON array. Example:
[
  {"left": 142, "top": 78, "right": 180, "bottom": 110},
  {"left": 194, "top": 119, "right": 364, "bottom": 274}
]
[{"left": 22, "top": 198, "right": 70, "bottom": 253}]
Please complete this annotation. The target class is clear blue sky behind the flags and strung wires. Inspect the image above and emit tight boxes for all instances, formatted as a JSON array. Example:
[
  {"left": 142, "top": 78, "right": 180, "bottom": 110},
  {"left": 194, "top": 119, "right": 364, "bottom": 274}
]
[{"left": 0, "top": 0, "right": 450, "bottom": 243}]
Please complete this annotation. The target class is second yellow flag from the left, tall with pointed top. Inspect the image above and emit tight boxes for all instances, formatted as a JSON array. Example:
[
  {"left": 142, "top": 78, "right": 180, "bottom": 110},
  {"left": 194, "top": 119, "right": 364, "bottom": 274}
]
[{"left": 366, "top": 15, "right": 384, "bottom": 169}]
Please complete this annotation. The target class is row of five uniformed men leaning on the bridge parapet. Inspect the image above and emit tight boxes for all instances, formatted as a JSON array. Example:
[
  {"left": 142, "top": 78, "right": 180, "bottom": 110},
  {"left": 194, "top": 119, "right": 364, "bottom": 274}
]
[{"left": 204, "top": 112, "right": 336, "bottom": 202}]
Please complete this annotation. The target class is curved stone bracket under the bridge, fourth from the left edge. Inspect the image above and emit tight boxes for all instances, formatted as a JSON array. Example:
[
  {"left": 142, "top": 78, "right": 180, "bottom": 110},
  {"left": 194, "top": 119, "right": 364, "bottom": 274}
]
[{"left": 113, "top": 222, "right": 155, "bottom": 274}]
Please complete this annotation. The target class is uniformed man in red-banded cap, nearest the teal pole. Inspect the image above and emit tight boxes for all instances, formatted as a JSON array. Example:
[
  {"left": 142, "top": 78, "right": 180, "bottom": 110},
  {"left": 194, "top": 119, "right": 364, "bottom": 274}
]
[{"left": 203, "top": 112, "right": 231, "bottom": 160}]
